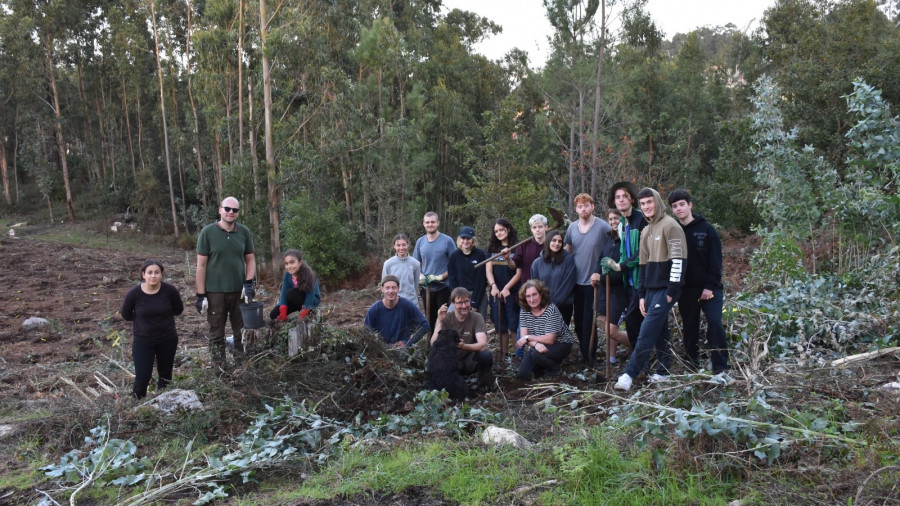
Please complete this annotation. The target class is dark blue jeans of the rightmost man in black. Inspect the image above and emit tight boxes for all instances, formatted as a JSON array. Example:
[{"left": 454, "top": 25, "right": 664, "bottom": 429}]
[{"left": 678, "top": 287, "right": 728, "bottom": 373}]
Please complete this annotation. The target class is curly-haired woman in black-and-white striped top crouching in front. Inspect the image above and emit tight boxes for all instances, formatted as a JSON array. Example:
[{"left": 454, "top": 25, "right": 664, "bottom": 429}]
[{"left": 516, "top": 279, "right": 575, "bottom": 380}]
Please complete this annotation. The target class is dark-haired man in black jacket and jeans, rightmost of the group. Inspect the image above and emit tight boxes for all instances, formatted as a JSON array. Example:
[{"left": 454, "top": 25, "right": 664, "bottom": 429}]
[{"left": 668, "top": 190, "right": 728, "bottom": 374}]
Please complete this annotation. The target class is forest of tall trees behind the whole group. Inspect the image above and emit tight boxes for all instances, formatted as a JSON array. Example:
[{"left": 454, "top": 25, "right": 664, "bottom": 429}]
[{"left": 0, "top": 0, "right": 900, "bottom": 286}]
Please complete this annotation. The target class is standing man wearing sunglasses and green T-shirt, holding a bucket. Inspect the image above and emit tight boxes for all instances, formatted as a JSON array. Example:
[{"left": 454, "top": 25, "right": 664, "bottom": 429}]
[{"left": 196, "top": 197, "right": 256, "bottom": 371}]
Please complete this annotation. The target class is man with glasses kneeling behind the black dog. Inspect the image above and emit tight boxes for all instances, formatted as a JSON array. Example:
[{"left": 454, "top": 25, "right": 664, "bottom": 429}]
[{"left": 431, "top": 286, "right": 494, "bottom": 391}]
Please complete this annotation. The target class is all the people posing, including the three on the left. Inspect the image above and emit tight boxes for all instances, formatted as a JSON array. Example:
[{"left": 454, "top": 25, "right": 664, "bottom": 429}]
[{"left": 120, "top": 182, "right": 728, "bottom": 398}]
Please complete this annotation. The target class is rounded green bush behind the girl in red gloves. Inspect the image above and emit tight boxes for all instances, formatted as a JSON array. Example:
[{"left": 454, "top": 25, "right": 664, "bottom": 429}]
[{"left": 282, "top": 194, "right": 363, "bottom": 279}]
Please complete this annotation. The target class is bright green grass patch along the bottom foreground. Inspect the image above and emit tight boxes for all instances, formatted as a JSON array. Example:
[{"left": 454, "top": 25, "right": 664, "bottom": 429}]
[{"left": 284, "top": 429, "right": 734, "bottom": 505}]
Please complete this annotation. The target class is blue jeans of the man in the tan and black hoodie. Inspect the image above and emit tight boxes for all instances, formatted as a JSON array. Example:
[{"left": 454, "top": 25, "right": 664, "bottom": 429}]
[{"left": 625, "top": 288, "right": 675, "bottom": 379}]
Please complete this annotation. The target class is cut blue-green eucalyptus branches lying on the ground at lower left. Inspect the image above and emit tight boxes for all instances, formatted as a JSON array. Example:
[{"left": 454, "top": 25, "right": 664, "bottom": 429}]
[{"left": 41, "top": 391, "right": 497, "bottom": 504}]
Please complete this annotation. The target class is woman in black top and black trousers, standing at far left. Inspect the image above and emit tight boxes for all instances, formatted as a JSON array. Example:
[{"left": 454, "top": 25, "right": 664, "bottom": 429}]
[{"left": 120, "top": 259, "right": 184, "bottom": 399}]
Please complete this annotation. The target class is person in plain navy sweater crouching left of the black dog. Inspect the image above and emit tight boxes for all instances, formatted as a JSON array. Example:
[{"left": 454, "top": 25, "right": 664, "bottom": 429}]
[{"left": 364, "top": 274, "right": 431, "bottom": 349}]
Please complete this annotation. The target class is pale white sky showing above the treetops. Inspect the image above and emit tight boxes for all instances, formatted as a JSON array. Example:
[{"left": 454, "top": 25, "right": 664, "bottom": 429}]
[{"left": 443, "top": 0, "right": 775, "bottom": 67}]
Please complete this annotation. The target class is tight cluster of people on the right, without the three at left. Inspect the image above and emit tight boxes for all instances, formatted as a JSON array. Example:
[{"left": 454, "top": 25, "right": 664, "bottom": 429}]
[{"left": 365, "top": 181, "right": 728, "bottom": 391}]
